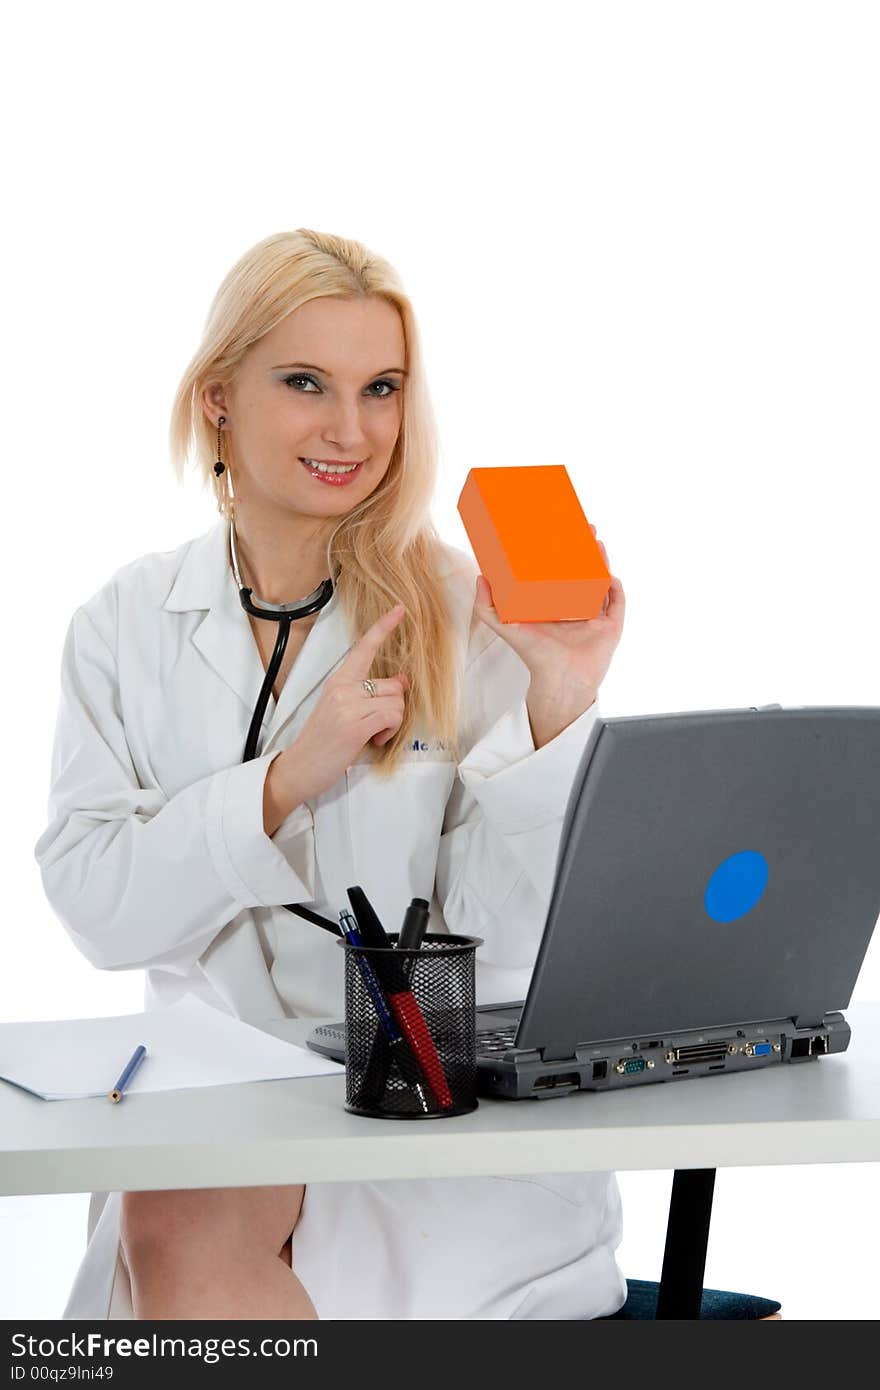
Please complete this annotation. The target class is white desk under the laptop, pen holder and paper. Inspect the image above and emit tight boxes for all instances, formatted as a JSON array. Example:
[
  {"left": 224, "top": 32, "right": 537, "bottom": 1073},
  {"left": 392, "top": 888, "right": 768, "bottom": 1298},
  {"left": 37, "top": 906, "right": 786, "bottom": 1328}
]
[{"left": 0, "top": 1004, "right": 880, "bottom": 1315}]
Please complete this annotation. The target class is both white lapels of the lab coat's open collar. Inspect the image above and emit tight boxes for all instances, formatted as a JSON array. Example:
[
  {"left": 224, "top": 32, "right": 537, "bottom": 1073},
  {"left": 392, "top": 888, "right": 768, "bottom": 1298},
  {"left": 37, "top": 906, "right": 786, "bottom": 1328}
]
[{"left": 163, "top": 520, "right": 352, "bottom": 753}]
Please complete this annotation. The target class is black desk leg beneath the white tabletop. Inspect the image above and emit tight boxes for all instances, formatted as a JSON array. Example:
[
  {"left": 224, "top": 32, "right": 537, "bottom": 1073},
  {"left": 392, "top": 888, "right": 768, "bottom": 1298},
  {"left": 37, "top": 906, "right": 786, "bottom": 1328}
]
[{"left": 655, "top": 1168, "right": 715, "bottom": 1318}]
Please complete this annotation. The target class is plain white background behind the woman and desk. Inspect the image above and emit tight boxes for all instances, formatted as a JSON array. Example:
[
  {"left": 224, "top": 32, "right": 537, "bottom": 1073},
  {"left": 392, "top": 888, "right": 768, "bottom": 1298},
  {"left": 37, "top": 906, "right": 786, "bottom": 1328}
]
[{"left": 0, "top": 0, "right": 880, "bottom": 1319}]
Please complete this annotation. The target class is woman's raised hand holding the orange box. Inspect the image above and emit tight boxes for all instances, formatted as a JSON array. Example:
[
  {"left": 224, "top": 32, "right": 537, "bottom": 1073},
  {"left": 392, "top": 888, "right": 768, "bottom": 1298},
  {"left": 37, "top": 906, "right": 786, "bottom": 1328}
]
[{"left": 474, "top": 525, "right": 626, "bottom": 737}]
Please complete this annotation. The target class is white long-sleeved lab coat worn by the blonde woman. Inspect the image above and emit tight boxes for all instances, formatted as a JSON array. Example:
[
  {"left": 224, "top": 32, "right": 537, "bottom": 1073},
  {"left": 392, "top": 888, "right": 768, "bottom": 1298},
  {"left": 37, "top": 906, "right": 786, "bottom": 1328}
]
[{"left": 35, "top": 520, "right": 626, "bottom": 1319}]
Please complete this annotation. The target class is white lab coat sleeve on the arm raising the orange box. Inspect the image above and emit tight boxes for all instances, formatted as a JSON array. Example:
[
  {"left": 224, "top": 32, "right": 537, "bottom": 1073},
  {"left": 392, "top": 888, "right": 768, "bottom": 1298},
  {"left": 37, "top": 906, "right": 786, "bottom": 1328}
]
[{"left": 435, "top": 634, "right": 599, "bottom": 978}]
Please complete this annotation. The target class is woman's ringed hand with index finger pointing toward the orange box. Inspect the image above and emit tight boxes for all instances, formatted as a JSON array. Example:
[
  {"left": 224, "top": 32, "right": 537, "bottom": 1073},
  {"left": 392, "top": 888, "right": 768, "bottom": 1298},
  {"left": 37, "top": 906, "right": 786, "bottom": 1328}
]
[{"left": 272, "top": 603, "right": 409, "bottom": 801}]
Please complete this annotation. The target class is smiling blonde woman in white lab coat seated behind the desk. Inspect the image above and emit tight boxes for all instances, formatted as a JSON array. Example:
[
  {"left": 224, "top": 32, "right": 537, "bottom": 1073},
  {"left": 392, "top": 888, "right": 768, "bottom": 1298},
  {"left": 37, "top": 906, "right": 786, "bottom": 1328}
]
[{"left": 35, "top": 229, "right": 626, "bottom": 1319}]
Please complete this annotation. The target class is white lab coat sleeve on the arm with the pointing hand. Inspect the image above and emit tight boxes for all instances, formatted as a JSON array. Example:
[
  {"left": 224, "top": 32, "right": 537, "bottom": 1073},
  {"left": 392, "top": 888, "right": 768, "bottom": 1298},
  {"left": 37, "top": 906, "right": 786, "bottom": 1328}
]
[{"left": 35, "top": 607, "right": 314, "bottom": 973}]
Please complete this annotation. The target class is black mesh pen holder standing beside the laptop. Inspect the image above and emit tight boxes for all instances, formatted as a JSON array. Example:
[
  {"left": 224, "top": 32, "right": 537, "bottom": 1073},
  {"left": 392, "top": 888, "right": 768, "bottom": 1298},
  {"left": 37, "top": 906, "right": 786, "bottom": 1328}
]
[{"left": 338, "top": 933, "right": 482, "bottom": 1120}]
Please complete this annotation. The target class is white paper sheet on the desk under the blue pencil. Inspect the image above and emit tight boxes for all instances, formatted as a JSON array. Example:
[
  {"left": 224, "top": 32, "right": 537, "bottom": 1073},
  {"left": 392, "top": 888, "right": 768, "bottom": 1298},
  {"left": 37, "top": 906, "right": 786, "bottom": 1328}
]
[{"left": 0, "top": 997, "right": 345, "bottom": 1101}]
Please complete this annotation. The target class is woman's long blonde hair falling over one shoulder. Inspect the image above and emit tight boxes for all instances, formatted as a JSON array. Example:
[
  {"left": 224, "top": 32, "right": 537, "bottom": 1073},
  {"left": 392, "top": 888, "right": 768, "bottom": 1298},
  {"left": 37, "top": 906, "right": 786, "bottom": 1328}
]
[{"left": 170, "top": 227, "right": 459, "bottom": 777}]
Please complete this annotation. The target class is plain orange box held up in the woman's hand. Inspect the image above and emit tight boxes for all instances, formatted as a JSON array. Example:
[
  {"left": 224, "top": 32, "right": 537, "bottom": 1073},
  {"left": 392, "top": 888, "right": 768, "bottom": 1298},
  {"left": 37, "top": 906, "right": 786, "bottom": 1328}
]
[{"left": 459, "top": 463, "right": 612, "bottom": 623}]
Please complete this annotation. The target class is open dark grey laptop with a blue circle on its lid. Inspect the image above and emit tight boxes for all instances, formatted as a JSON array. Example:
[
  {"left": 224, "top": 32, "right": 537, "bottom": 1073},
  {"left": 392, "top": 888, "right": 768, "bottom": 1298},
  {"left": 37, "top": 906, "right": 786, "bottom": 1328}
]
[{"left": 307, "top": 705, "right": 880, "bottom": 1099}]
